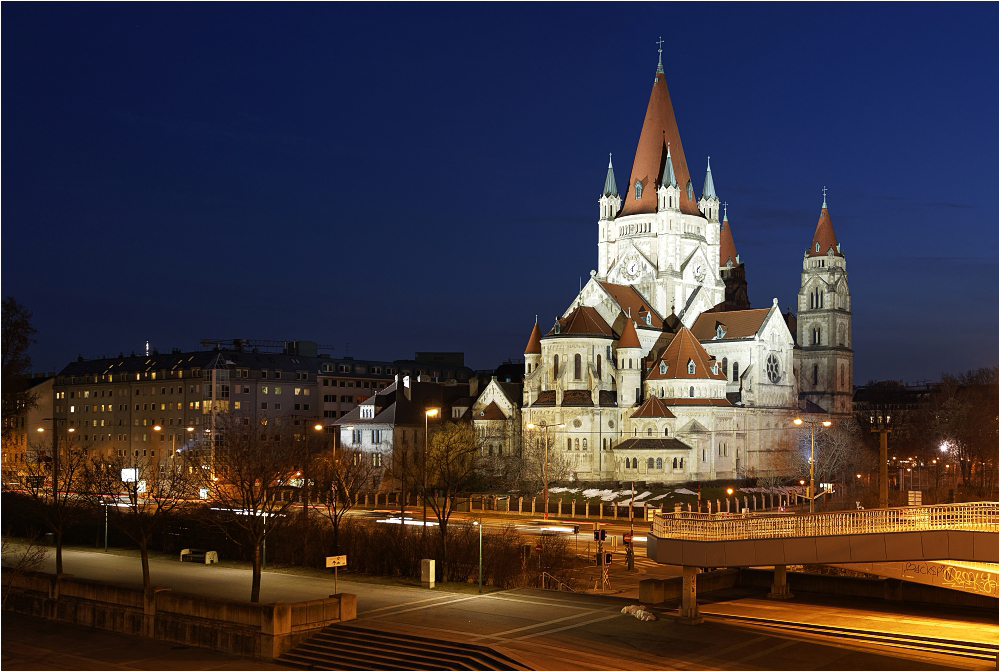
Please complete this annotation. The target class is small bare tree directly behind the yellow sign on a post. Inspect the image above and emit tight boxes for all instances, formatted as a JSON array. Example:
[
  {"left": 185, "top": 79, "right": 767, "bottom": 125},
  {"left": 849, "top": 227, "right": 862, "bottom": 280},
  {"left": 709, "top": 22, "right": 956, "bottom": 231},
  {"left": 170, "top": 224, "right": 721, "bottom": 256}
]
[{"left": 309, "top": 450, "right": 382, "bottom": 555}]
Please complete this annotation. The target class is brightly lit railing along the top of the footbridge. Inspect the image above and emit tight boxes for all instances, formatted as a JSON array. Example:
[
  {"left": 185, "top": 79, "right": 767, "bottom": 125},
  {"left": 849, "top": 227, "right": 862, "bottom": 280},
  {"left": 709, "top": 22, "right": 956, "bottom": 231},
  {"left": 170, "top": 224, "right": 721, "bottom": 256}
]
[{"left": 652, "top": 502, "right": 1000, "bottom": 541}]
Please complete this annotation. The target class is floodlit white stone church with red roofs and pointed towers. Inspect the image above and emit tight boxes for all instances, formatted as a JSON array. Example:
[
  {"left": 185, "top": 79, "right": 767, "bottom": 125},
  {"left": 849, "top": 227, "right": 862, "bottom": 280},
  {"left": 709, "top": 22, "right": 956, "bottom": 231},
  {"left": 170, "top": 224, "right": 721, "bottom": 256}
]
[{"left": 471, "top": 50, "right": 853, "bottom": 483}]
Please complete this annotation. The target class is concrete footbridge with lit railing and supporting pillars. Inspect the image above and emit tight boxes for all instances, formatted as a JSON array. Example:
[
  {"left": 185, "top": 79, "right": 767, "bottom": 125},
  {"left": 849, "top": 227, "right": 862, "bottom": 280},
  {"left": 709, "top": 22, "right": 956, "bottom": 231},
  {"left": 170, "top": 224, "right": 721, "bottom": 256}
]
[{"left": 646, "top": 502, "right": 1000, "bottom": 623}]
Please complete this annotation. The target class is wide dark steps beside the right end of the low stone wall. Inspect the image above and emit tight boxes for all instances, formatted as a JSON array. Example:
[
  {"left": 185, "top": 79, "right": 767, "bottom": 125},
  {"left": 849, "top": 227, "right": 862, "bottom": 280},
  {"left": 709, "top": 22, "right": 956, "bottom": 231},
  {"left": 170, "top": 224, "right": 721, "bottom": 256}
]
[{"left": 276, "top": 623, "right": 528, "bottom": 670}]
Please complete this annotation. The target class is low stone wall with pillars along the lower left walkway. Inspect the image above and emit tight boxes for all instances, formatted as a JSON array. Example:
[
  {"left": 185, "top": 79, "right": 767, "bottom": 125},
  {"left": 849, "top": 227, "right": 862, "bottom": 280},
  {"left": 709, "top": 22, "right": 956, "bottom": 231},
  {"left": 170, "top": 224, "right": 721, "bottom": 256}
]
[{"left": 3, "top": 571, "right": 357, "bottom": 659}]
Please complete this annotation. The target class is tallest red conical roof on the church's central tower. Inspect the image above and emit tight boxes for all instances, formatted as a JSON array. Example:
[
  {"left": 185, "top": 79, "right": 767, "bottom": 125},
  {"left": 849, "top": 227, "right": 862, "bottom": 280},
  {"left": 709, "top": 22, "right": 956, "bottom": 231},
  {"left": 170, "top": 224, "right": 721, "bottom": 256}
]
[{"left": 621, "top": 60, "right": 703, "bottom": 217}]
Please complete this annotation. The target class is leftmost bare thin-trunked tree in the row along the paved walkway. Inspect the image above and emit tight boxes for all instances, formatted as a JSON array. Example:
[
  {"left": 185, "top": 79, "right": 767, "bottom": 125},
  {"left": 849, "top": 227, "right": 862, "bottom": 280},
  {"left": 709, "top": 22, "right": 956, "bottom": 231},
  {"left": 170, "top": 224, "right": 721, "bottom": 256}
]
[{"left": 13, "top": 434, "right": 88, "bottom": 574}]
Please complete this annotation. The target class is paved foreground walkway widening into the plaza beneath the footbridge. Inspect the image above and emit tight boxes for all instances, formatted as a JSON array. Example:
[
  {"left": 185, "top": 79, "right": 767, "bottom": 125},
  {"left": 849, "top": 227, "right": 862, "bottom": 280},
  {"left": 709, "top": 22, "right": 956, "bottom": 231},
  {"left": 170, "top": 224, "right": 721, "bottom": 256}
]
[{"left": 13, "top": 549, "right": 1000, "bottom": 670}]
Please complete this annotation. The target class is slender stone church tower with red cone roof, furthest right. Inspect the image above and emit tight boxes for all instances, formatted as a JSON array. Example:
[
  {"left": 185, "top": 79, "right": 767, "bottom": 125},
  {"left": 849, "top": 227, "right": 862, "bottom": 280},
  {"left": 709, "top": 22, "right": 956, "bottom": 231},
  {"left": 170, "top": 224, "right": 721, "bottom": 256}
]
[{"left": 795, "top": 188, "right": 854, "bottom": 415}]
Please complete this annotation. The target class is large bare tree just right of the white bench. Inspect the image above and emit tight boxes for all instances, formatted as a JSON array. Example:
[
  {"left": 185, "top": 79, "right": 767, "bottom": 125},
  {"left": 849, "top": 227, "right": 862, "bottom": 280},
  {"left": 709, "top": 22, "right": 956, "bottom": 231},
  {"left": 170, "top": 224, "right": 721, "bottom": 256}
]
[{"left": 187, "top": 413, "right": 308, "bottom": 602}]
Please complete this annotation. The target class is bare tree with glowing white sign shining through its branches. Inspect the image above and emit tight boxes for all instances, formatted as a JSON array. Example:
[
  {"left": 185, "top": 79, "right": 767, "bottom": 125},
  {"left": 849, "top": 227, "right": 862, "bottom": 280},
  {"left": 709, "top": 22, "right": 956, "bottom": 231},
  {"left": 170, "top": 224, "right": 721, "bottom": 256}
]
[{"left": 84, "top": 451, "right": 193, "bottom": 588}]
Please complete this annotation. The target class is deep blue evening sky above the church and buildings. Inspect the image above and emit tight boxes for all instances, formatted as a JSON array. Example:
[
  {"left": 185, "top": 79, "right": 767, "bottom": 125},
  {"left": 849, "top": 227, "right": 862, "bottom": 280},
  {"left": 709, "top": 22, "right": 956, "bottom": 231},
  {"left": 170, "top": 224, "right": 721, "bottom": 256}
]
[{"left": 2, "top": 3, "right": 998, "bottom": 384}]
